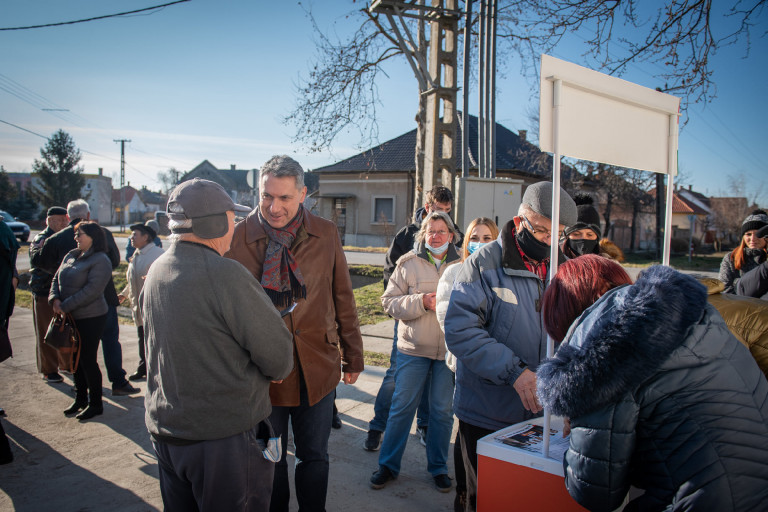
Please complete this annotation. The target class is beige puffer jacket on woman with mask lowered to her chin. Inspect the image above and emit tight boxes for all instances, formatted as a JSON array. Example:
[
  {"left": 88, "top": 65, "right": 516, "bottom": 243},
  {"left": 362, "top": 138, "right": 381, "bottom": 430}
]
[{"left": 381, "top": 243, "right": 459, "bottom": 360}]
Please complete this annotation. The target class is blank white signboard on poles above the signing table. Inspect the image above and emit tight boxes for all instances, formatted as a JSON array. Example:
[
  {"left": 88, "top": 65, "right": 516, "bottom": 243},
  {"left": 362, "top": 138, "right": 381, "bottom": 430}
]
[{"left": 539, "top": 55, "right": 680, "bottom": 175}]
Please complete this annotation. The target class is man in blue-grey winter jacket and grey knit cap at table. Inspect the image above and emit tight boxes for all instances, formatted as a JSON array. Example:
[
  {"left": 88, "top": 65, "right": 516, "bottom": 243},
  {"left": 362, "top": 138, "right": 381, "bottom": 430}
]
[{"left": 445, "top": 181, "right": 577, "bottom": 510}]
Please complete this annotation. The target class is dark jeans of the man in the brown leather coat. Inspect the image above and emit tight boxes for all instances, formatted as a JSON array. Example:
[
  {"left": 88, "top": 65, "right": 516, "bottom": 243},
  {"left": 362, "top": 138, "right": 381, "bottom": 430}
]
[{"left": 269, "top": 376, "right": 334, "bottom": 512}]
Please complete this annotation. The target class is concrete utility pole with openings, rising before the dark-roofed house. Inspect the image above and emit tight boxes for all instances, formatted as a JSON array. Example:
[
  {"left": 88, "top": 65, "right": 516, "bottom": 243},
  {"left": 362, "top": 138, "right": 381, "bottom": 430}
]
[{"left": 370, "top": 0, "right": 462, "bottom": 205}]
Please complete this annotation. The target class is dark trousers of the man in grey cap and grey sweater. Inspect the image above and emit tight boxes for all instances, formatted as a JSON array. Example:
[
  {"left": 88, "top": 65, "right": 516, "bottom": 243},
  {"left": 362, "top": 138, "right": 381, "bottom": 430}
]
[{"left": 152, "top": 425, "right": 275, "bottom": 512}]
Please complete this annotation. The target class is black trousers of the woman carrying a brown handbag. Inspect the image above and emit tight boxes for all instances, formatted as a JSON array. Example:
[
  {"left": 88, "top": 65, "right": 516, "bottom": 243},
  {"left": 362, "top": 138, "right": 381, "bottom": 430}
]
[{"left": 75, "top": 315, "right": 107, "bottom": 408}]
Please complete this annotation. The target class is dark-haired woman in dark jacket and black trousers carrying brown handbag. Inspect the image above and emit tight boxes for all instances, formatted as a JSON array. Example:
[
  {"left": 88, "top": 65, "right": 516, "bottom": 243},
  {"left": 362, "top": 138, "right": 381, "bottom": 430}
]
[{"left": 48, "top": 221, "right": 112, "bottom": 421}]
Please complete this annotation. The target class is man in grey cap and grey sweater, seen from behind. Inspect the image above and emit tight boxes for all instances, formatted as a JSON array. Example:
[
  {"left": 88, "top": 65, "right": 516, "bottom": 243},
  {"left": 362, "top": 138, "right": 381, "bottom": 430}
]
[{"left": 140, "top": 179, "right": 293, "bottom": 512}]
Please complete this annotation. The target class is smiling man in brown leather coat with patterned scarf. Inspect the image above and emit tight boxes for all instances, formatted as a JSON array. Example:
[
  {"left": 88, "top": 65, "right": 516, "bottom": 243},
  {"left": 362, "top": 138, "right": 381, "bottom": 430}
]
[{"left": 227, "top": 156, "right": 363, "bottom": 512}]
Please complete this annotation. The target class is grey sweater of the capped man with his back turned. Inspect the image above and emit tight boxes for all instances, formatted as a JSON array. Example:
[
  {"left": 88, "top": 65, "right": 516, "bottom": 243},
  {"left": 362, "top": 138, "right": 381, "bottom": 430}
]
[{"left": 140, "top": 242, "right": 293, "bottom": 441}]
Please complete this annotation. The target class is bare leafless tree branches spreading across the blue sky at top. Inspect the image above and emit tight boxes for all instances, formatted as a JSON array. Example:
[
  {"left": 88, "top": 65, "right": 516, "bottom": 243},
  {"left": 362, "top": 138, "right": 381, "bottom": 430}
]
[{"left": 284, "top": 0, "right": 768, "bottom": 151}]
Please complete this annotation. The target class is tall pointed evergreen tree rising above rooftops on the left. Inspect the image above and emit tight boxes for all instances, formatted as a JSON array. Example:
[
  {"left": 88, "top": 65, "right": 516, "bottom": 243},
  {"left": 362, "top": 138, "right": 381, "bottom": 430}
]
[{"left": 29, "top": 130, "right": 85, "bottom": 208}]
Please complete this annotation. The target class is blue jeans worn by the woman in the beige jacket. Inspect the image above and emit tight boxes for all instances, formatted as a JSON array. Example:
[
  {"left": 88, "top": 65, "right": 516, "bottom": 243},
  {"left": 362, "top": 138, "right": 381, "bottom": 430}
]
[{"left": 379, "top": 352, "right": 453, "bottom": 476}]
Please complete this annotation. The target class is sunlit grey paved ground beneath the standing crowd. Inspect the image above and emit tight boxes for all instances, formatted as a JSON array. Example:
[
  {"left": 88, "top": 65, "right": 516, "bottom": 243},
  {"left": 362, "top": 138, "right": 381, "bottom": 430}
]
[{"left": 0, "top": 308, "right": 454, "bottom": 512}]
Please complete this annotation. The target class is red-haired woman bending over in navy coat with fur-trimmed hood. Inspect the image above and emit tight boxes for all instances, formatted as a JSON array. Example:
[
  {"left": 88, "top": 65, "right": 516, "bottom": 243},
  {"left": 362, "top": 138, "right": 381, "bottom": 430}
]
[{"left": 536, "top": 255, "right": 768, "bottom": 511}]
